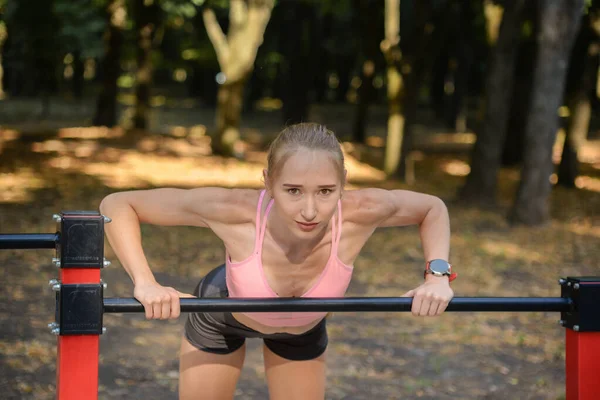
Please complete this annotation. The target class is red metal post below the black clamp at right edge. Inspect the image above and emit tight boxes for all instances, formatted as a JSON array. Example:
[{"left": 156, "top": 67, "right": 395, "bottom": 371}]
[{"left": 565, "top": 329, "right": 600, "bottom": 400}]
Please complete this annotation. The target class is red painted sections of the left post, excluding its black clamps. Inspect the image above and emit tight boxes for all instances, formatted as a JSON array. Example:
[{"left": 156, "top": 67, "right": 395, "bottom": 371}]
[{"left": 56, "top": 268, "right": 100, "bottom": 400}]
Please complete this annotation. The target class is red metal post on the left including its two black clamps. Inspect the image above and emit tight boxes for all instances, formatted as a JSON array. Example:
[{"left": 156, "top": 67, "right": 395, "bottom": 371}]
[{"left": 52, "top": 211, "right": 105, "bottom": 400}]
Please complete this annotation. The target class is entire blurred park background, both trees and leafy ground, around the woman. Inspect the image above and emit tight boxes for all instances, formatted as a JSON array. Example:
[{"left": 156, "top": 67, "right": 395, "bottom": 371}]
[{"left": 0, "top": 0, "right": 600, "bottom": 400}]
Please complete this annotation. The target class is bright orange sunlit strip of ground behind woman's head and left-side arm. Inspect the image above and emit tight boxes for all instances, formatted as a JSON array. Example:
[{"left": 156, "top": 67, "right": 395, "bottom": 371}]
[{"left": 0, "top": 127, "right": 385, "bottom": 202}]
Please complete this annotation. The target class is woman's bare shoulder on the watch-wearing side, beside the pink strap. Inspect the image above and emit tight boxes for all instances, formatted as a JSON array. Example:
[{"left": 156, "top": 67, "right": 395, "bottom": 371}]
[{"left": 342, "top": 188, "right": 395, "bottom": 226}]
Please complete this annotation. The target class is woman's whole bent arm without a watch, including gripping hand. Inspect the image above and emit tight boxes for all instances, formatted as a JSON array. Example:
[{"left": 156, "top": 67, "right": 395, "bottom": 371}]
[{"left": 100, "top": 188, "right": 256, "bottom": 319}]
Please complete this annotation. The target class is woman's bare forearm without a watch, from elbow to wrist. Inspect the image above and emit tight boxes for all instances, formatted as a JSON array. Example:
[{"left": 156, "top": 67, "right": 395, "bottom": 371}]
[{"left": 100, "top": 196, "right": 155, "bottom": 284}]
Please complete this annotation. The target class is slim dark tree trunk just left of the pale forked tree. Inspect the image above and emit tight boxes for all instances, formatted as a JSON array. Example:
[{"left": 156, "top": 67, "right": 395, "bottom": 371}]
[{"left": 133, "top": 0, "right": 159, "bottom": 130}]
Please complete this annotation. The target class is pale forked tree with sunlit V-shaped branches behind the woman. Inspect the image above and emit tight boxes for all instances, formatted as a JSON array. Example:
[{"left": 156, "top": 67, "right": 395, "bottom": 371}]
[{"left": 202, "top": 0, "right": 275, "bottom": 155}]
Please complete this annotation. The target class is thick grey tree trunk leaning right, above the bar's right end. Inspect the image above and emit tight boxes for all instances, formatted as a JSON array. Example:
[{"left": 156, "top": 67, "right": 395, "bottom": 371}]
[{"left": 509, "top": 0, "right": 583, "bottom": 225}]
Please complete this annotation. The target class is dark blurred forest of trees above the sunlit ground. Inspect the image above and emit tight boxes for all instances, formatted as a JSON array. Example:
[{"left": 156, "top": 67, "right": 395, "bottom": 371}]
[{"left": 0, "top": 0, "right": 600, "bottom": 225}]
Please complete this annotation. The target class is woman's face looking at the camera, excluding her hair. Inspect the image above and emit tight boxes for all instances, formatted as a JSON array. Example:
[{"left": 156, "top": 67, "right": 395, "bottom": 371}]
[{"left": 265, "top": 149, "right": 343, "bottom": 237}]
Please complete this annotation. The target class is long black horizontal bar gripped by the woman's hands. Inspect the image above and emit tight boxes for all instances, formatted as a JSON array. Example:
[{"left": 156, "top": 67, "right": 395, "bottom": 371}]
[{"left": 104, "top": 297, "right": 572, "bottom": 313}]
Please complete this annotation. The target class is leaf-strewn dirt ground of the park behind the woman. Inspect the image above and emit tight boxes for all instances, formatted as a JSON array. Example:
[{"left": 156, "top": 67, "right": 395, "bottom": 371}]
[{"left": 0, "top": 99, "right": 600, "bottom": 400}]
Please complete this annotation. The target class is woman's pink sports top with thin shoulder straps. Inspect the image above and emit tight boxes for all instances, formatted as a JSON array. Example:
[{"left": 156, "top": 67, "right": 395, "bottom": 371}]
[{"left": 226, "top": 190, "right": 353, "bottom": 327}]
